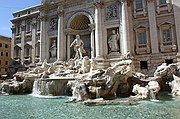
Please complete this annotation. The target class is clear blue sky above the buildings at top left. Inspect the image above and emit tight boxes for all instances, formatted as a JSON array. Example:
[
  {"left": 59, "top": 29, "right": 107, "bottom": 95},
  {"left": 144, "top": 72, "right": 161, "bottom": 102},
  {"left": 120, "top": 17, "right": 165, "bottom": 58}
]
[{"left": 0, "top": 0, "right": 40, "bottom": 37}]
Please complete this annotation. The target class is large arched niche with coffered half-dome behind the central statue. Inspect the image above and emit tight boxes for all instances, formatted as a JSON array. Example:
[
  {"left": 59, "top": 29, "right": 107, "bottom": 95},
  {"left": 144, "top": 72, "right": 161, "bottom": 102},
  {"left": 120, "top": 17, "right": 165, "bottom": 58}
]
[{"left": 67, "top": 12, "right": 94, "bottom": 58}]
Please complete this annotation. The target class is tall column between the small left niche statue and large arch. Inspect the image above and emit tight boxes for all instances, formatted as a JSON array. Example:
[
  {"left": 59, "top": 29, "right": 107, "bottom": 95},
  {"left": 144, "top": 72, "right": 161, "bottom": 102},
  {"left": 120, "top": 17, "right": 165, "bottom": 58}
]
[{"left": 57, "top": 10, "right": 65, "bottom": 61}]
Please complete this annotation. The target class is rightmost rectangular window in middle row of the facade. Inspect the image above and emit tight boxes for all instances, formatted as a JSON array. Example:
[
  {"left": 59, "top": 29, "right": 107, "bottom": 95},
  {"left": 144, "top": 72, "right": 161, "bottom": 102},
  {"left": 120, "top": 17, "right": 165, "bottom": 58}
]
[{"left": 162, "top": 28, "right": 172, "bottom": 42}]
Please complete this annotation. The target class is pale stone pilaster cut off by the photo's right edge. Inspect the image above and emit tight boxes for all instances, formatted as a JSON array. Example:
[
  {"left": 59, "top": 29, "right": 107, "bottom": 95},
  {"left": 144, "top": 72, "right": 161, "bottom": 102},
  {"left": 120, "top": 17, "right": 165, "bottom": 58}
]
[{"left": 172, "top": 0, "right": 180, "bottom": 61}]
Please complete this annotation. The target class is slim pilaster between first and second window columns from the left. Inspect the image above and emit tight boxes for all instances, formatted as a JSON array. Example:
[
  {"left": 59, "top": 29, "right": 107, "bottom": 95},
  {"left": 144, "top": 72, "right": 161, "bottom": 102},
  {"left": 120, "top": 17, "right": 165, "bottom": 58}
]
[{"left": 21, "top": 21, "right": 26, "bottom": 65}]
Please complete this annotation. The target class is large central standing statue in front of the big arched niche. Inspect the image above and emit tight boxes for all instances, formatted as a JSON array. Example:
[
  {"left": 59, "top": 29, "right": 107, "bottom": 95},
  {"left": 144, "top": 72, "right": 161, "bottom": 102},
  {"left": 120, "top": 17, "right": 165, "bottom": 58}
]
[{"left": 70, "top": 34, "right": 86, "bottom": 59}]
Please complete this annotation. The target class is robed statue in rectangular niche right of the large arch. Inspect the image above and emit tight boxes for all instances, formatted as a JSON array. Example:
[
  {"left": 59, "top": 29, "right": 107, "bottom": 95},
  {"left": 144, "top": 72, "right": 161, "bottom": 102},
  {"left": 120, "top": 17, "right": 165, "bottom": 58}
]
[{"left": 108, "top": 30, "right": 119, "bottom": 52}]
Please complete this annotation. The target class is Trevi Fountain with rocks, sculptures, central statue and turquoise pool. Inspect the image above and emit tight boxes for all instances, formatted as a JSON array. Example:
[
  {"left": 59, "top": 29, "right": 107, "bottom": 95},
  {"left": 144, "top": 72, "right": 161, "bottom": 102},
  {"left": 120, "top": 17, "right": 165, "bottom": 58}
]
[{"left": 0, "top": 35, "right": 180, "bottom": 119}]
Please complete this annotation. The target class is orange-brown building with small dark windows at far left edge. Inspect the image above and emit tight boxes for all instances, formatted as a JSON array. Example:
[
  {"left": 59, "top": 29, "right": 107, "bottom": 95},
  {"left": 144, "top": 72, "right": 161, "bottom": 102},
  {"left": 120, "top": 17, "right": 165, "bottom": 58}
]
[{"left": 0, "top": 35, "right": 11, "bottom": 75}]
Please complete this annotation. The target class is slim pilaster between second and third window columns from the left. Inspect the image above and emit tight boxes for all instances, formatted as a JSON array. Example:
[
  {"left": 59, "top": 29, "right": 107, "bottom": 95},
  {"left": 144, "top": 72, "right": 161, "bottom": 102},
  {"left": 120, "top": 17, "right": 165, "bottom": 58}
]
[{"left": 31, "top": 18, "right": 37, "bottom": 64}]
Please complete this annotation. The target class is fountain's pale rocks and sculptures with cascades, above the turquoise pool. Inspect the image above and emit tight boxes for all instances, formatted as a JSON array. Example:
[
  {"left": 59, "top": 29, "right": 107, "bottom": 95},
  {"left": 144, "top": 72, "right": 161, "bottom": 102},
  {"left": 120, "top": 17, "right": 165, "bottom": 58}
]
[{"left": 0, "top": 36, "right": 180, "bottom": 104}]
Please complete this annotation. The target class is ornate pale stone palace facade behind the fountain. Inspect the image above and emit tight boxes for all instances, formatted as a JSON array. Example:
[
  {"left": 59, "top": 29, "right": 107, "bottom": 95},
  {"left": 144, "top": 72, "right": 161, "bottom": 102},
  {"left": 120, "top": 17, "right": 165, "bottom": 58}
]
[{"left": 11, "top": 0, "right": 180, "bottom": 74}]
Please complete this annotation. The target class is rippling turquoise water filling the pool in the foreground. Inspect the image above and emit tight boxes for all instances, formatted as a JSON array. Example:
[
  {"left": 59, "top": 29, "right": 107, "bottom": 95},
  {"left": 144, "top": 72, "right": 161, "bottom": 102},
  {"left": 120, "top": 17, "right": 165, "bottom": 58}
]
[{"left": 0, "top": 94, "right": 180, "bottom": 119}]
